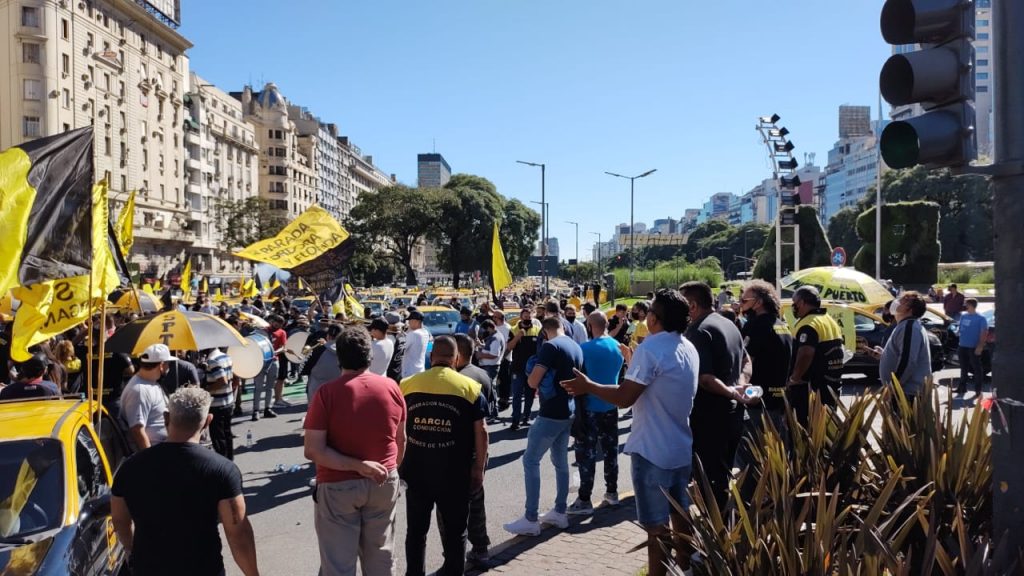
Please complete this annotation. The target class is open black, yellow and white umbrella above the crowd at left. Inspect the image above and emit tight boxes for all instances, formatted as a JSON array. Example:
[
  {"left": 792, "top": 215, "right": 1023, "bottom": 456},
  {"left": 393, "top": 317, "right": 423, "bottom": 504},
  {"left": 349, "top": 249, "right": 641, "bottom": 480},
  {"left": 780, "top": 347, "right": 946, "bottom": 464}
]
[{"left": 106, "top": 311, "right": 246, "bottom": 356}]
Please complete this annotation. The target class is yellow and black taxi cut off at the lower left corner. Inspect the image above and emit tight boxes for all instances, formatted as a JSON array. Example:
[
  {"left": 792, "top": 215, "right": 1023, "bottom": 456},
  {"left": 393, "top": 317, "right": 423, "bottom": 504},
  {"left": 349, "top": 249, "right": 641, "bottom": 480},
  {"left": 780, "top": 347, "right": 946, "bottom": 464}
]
[{"left": 0, "top": 399, "right": 129, "bottom": 576}]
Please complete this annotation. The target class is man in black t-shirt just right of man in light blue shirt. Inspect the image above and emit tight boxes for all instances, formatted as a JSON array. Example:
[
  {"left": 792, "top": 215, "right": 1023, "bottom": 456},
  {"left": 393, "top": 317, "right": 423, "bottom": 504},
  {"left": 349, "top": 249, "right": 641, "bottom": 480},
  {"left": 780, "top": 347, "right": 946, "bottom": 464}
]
[{"left": 680, "top": 282, "right": 745, "bottom": 509}]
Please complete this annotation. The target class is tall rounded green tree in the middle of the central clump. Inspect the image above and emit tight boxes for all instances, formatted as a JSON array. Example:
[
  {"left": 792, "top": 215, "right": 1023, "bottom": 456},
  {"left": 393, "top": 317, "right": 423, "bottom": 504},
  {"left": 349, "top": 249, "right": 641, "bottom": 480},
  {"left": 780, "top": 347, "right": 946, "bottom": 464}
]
[{"left": 429, "top": 174, "right": 505, "bottom": 289}]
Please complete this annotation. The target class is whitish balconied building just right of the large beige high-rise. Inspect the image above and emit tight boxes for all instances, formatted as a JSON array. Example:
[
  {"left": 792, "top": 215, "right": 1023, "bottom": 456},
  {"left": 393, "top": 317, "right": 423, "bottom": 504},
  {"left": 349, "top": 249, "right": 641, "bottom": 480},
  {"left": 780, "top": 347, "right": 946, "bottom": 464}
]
[{"left": 183, "top": 73, "right": 259, "bottom": 285}]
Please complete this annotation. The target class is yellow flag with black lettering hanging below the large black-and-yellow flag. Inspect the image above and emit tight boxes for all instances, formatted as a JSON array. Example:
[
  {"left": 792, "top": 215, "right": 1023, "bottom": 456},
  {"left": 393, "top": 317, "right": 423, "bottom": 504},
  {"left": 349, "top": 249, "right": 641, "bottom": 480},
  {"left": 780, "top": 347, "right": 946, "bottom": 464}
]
[{"left": 11, "top": 181, "right": 120, "bottom": 362}]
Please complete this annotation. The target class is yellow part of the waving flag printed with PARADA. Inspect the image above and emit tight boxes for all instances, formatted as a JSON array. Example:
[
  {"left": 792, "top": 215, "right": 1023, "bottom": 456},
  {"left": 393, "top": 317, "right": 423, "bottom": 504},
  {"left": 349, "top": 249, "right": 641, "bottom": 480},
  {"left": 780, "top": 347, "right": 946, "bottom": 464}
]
[{"left": 236, "top": 206, "right": 348, "bottom": 270}]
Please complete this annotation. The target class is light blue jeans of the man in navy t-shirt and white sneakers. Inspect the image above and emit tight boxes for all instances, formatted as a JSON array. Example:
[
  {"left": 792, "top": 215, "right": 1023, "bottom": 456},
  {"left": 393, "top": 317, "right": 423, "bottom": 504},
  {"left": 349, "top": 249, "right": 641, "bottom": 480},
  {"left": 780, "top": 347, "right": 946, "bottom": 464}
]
[{"left": 522, "top": 416, "right": 572, "bottom": 522}]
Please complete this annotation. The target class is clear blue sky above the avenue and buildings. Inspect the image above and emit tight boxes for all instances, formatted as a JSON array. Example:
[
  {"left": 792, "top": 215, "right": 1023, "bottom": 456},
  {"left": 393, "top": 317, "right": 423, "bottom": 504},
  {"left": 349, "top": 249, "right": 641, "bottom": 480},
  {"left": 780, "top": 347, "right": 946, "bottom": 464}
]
[{"left": 180, "top": 0, "right": 890, "bottom": 259}]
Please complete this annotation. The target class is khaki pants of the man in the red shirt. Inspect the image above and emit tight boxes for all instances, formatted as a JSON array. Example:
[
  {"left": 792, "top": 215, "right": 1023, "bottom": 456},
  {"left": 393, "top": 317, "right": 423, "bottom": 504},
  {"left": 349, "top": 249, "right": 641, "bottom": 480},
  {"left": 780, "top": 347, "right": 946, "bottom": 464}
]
[{"left": 314, "top": 470, "right": 400, "bottom": 576}]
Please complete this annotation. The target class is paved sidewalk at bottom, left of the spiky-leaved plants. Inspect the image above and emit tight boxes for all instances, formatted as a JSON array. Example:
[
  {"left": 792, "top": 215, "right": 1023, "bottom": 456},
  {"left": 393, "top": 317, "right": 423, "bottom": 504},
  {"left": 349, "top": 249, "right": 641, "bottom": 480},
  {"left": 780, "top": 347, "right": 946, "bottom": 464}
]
[{"left": 466, "top": 494, "right": 647, "bottom": 576}]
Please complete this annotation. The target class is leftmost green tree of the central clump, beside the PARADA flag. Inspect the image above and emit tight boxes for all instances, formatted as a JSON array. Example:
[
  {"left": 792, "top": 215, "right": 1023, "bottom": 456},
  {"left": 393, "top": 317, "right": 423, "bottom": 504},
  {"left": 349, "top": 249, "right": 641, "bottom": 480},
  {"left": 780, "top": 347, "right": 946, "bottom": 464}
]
[{"left": 348, "top": 184, "right": 437, "bottom": 285}]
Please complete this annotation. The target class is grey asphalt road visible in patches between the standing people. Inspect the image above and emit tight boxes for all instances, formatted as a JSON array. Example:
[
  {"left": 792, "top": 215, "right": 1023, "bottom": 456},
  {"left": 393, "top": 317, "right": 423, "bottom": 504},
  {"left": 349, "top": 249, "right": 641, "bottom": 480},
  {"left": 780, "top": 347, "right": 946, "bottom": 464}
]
[{"left": 224, "top": 360, "right": 988, "bottom": 575}]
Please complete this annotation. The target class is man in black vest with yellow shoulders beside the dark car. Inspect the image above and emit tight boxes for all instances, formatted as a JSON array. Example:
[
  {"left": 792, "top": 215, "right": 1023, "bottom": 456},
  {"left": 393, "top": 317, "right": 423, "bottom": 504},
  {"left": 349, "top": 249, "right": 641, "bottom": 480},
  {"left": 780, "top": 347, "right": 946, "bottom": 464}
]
[{"left": 786, "top": 286, "right": 843, "bottom": 426}]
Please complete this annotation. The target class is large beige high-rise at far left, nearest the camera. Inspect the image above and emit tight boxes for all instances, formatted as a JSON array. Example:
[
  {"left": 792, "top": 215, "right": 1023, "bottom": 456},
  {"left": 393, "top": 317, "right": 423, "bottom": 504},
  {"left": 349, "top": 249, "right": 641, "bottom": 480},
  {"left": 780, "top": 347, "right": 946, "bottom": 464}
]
[{"left": 0, "top": 0, "right": 193, "bottom": 271}]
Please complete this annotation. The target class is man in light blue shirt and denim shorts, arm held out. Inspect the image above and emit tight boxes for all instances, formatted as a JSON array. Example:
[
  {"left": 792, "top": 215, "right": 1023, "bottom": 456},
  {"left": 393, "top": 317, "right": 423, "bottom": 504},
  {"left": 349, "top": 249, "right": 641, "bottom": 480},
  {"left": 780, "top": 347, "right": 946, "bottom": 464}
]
[{"left": 561, "top": 290, "right": 700, "bottom": 576}]
